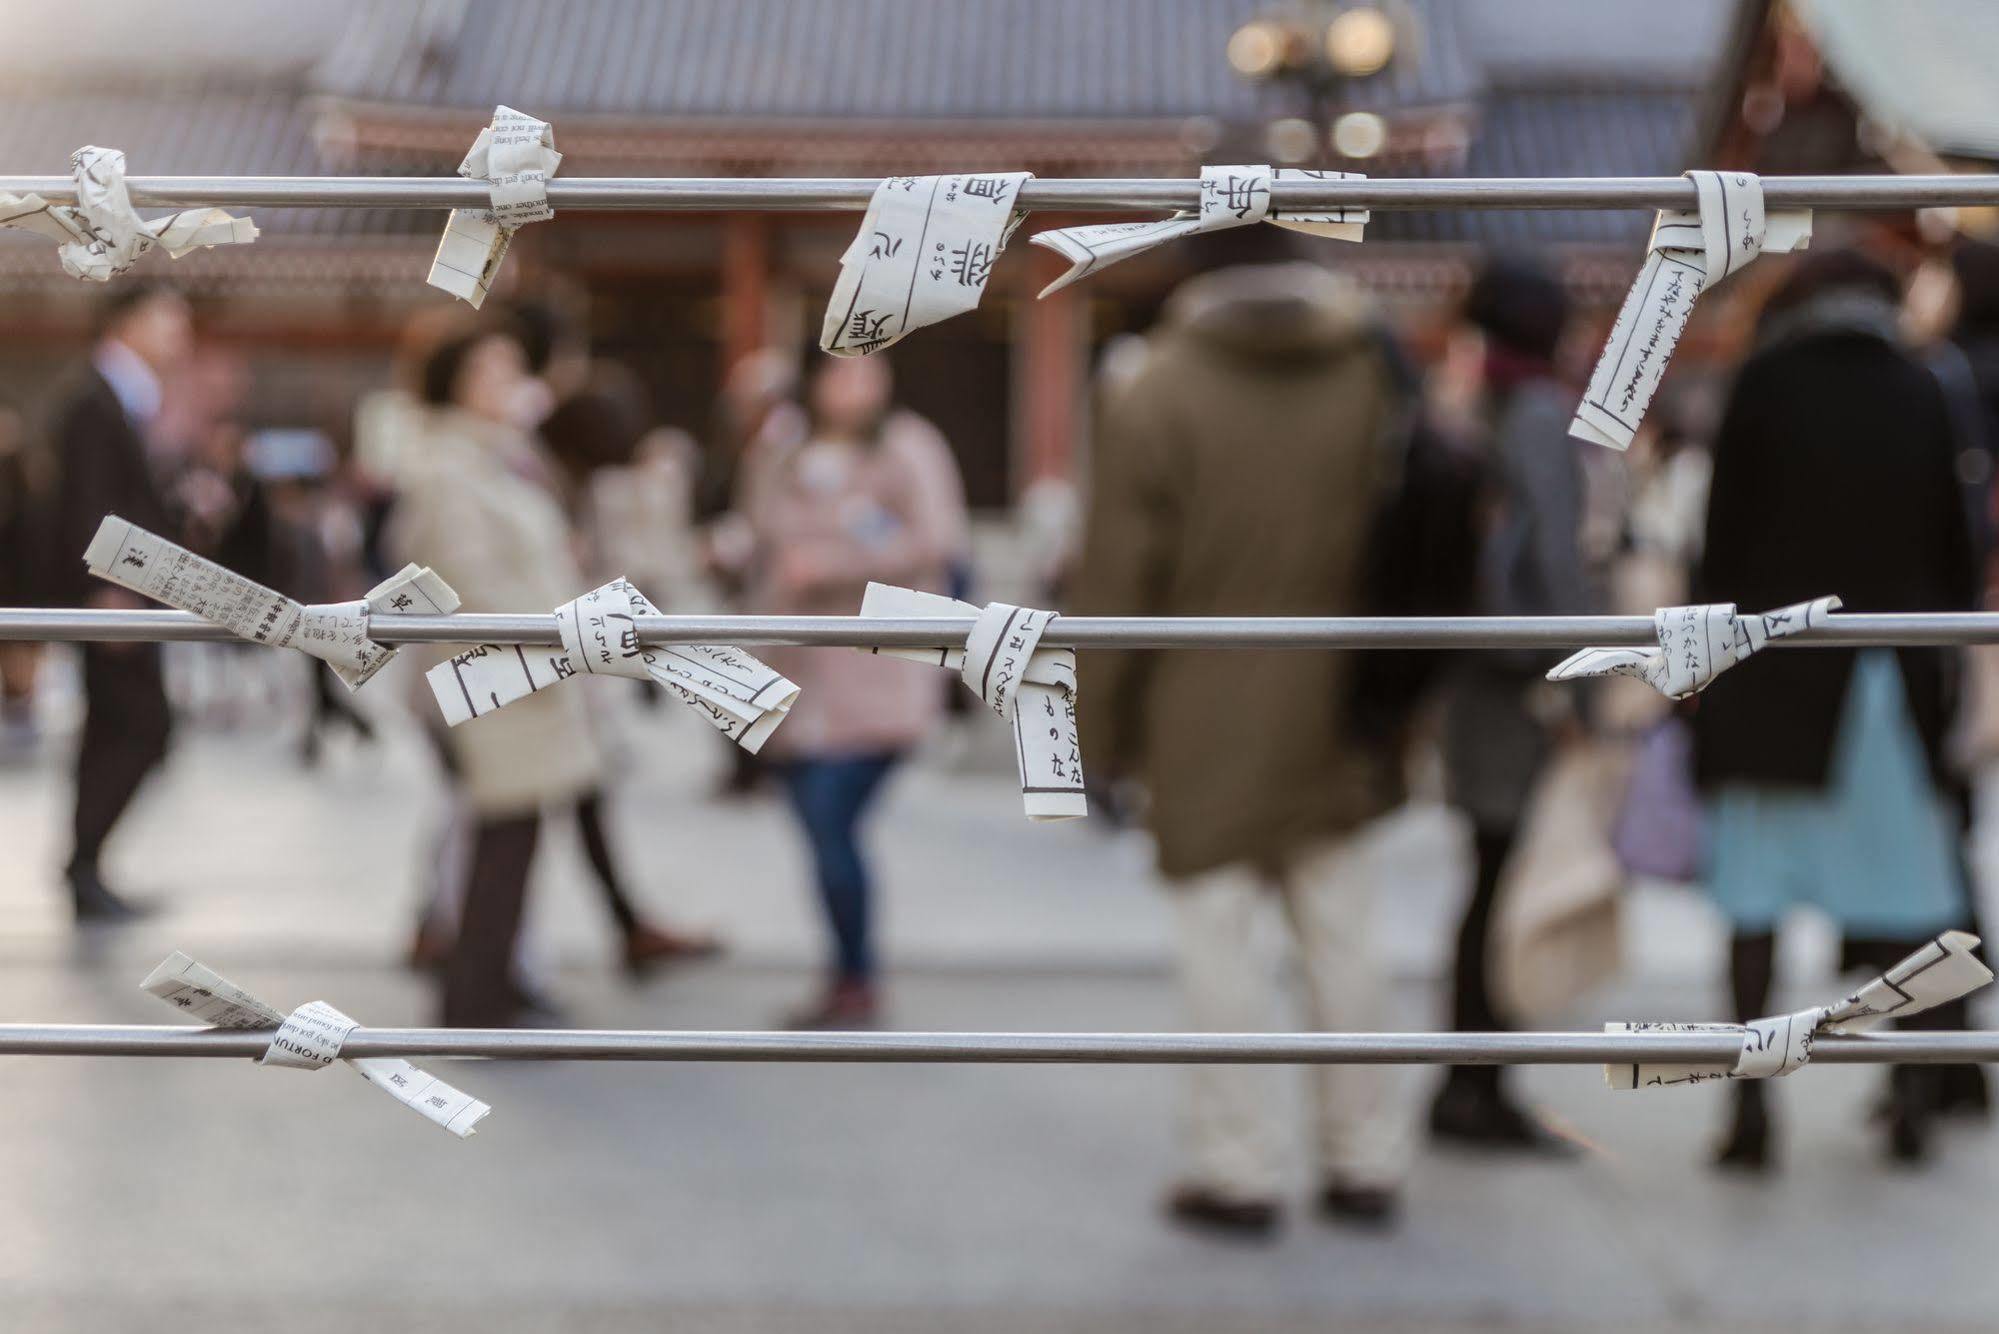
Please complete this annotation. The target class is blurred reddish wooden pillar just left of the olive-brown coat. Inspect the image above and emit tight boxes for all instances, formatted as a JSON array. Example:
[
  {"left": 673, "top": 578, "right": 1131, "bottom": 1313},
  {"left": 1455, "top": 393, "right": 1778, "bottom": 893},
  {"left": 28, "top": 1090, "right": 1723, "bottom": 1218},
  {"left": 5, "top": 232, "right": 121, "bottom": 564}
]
[{"left": 1013, "top": 246, "right": 1089, "bottom": 494}]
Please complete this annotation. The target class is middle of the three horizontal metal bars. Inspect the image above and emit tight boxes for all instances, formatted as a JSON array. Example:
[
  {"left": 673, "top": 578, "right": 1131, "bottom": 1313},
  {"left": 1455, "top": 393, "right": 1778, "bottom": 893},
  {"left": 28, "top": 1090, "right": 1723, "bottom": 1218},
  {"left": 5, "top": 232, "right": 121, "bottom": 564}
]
[{"left": 0, "top": 608, "right": 1999, "bottom": 648}]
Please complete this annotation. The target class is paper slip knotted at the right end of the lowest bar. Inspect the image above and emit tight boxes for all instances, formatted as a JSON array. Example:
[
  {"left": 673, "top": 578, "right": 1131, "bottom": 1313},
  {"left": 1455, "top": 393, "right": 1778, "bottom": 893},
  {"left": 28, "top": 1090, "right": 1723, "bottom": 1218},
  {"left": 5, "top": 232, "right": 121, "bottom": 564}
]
[{"left": 1603, "top": 932, "right": 1993, "bottom": 1090}]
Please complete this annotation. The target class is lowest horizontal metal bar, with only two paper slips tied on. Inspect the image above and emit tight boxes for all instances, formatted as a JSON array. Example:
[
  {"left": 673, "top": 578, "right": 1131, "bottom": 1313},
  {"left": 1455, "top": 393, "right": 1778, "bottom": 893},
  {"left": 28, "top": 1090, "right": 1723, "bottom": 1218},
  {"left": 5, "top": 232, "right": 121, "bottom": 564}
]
[{"left": 0, "top": 1024, "right": 1999, "bottom": 1066}]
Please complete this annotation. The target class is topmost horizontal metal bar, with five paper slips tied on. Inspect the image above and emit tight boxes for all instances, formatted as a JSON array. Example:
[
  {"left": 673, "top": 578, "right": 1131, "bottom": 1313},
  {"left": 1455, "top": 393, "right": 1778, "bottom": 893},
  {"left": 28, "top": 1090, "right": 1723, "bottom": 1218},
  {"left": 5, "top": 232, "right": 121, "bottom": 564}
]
[{"left": 0, "top": 176, "right": 1999, "bottom": 212}]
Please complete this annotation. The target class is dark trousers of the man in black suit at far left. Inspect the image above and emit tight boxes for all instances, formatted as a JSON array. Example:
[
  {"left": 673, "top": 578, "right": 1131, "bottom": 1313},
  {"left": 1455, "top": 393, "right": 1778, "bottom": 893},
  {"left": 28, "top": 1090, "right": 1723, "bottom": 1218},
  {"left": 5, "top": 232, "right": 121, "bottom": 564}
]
[{"left": 70, "top": 644, "right": 172, "bottom": 876}]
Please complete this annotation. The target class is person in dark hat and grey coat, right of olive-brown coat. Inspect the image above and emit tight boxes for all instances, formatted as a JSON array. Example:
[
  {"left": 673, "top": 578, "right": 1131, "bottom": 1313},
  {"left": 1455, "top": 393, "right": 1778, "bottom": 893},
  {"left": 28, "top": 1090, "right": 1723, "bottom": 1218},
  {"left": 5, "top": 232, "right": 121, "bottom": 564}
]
[{"left": 1429, "top": 258, "right": 1595, "bottom": 1152}]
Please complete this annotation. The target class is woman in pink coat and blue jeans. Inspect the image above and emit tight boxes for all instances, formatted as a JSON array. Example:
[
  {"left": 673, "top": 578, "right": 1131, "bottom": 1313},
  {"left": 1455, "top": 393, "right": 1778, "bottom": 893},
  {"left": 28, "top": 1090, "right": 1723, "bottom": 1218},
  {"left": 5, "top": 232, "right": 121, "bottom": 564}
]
[{"left": 750, "top": 356, "right": 966, "bottom": 1028}]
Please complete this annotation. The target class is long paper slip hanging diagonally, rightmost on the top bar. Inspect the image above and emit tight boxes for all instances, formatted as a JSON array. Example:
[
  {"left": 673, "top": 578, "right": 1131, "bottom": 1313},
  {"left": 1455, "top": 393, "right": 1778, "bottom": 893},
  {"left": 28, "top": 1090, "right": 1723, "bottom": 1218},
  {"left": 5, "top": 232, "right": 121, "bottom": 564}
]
[{"left": 1569, "top": 172, "right": 1811, "bottom": 450}]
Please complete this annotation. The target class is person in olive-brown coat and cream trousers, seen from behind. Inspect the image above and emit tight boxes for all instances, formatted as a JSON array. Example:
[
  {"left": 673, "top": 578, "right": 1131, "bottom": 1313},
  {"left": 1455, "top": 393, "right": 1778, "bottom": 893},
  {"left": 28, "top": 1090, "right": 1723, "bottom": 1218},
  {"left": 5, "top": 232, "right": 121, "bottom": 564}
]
[{"left": 1071, "top": 228, "right": 1405, "bottom": 1234}]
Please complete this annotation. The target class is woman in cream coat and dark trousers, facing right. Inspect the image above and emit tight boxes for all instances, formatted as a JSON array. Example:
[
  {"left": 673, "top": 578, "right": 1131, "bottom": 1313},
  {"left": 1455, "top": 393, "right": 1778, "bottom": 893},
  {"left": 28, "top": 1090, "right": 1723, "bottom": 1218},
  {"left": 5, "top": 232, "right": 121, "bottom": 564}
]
[{"left": 394, "top": 326, "right": 712, "bottom": 1028}]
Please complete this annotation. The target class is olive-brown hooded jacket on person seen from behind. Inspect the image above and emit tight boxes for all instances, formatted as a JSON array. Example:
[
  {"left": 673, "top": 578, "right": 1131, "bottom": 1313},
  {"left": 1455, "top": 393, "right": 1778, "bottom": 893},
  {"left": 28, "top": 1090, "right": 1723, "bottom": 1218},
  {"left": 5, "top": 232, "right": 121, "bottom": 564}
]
[{"left": 1071, "top": 264, "right": 1401, "bottom": 876}]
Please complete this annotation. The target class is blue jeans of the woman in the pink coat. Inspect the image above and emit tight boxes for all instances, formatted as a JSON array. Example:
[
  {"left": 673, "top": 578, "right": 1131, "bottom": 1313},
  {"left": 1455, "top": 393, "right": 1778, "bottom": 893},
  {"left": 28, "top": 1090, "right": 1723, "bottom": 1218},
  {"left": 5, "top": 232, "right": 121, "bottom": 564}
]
[{"left": 782, "top": 750, "right": 902, "bottom": 982}]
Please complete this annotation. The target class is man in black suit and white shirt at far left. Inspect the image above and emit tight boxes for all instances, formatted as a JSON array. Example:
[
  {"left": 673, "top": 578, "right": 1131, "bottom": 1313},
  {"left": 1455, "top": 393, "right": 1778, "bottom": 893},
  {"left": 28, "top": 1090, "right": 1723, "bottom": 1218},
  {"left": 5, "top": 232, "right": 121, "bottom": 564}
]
[{"left": 42, "top": 284, "right": 194, "bottom": 922}]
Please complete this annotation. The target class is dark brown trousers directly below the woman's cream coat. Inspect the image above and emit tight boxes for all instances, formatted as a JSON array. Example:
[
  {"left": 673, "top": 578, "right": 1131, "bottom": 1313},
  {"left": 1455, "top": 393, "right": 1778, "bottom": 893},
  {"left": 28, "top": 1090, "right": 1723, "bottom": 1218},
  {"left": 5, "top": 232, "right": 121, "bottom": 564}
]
[{"left": 444, "top": 812, "right": 542, "bottom": 1028}]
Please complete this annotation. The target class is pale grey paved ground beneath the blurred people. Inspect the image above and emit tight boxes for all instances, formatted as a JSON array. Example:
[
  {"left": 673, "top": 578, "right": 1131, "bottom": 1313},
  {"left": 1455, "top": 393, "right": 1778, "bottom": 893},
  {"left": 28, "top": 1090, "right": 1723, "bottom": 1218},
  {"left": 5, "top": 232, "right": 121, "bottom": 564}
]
[{"left": 0, "top": 644, "right": 1999, "bottom": 1334}]
